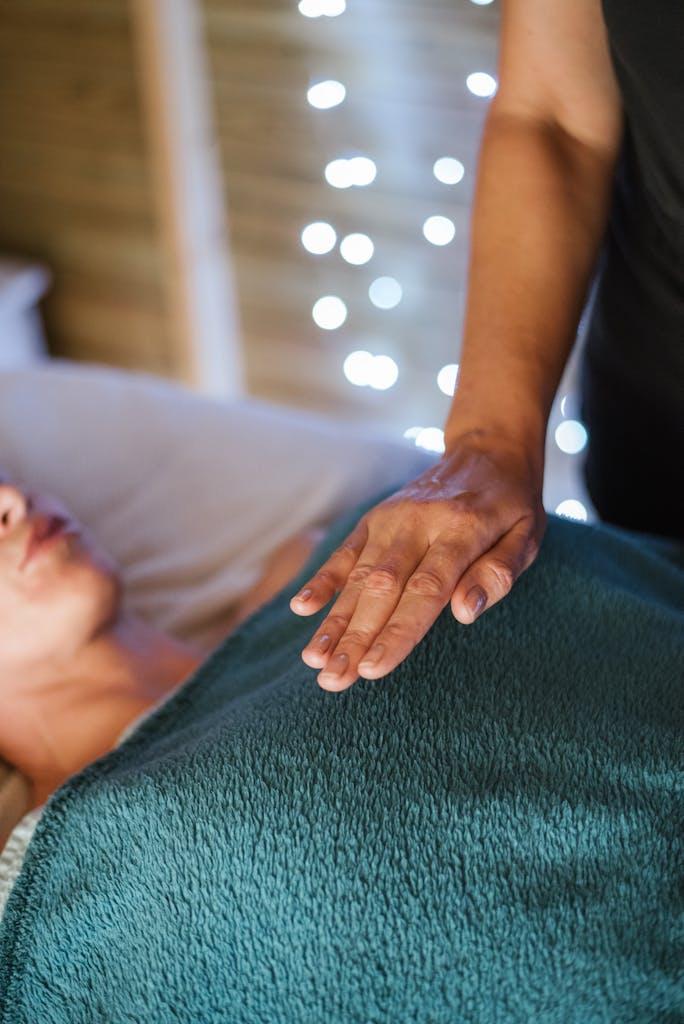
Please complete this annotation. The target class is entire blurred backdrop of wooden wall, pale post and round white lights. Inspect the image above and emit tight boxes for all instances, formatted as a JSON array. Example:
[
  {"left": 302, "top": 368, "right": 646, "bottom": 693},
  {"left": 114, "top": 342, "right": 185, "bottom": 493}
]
[{"left": 0, "top": 0, "right": 592, "bottom": 517}]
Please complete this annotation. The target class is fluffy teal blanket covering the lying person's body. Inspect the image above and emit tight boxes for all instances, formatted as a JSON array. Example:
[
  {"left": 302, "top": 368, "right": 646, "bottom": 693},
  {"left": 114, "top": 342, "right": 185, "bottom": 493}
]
[{"left": 0, "top": 507, "right": 684, "bottom": 1024}]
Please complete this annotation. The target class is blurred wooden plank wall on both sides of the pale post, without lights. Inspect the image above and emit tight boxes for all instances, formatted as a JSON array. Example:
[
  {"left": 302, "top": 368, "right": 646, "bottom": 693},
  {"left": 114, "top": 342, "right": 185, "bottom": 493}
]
[{"left": 0, "top": 0, "right": 498, "bottom": 430}]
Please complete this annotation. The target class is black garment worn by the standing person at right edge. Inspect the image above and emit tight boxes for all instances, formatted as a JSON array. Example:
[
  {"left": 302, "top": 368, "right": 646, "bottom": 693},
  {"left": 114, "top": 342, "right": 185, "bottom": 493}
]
[{"left": 583, "top": 0, "right": 684, "bottom": 537}]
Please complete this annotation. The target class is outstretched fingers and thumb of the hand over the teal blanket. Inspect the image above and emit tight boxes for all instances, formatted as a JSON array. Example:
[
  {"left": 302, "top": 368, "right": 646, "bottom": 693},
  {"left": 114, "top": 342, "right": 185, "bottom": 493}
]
[{"left": 291, "top": 507, "right": 544, "bottom": 691}]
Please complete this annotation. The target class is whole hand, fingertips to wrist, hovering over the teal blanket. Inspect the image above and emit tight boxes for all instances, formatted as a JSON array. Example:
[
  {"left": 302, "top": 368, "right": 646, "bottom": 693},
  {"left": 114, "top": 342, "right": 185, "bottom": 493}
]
[{"left": 290, "top": 434, "right": 546, "bottom": 690}]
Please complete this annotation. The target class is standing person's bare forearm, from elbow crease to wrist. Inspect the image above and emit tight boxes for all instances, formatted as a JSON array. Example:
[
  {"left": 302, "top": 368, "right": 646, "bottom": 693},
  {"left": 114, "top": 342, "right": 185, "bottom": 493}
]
[{"left": 445, "top": 100, "right": 614, "bottom": 451}]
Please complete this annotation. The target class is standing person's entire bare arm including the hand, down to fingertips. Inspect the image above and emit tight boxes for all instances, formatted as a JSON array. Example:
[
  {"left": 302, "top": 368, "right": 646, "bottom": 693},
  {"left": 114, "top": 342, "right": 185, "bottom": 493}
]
[{"left": 292, "top": 0, "right": 623, "bottom": 690}]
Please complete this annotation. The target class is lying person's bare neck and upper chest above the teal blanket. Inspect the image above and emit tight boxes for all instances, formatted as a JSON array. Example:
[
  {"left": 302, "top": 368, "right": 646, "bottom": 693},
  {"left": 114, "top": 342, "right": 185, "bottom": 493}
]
[{"left": 0, "top": 616, "right": 201, "bottom": 807}]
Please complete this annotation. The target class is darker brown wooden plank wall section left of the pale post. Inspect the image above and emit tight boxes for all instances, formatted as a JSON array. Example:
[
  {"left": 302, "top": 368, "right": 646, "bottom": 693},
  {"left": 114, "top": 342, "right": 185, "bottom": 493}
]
[{"left": 0, "top": 0, "right": 174, "bottom": 377}]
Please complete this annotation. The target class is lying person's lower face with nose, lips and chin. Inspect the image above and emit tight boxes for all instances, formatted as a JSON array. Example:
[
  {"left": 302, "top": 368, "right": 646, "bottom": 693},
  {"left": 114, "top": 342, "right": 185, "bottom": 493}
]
[{"left": 0, "top": 471, "right": 120, "bottom": 673}]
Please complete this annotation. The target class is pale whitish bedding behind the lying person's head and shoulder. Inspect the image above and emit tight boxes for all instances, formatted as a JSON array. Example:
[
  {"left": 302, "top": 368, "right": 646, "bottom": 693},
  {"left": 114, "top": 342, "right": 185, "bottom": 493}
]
[{"left": 0, "top": 361, "right": 432, "bottom": 643}]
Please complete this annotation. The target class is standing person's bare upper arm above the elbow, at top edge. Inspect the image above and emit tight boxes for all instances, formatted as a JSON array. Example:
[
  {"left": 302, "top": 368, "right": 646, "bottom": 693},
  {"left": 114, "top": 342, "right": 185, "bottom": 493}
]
[{"left": 493, "top": 0, "right": 623, "bottom": 153}]
